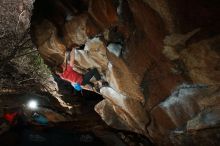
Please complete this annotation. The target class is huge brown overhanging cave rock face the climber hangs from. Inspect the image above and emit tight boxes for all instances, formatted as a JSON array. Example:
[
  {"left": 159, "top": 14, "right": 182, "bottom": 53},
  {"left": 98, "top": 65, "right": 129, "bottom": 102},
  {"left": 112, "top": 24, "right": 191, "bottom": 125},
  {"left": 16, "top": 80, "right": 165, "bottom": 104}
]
[{"left": 32, "top": 0, "right": 220, "bottom": 146}]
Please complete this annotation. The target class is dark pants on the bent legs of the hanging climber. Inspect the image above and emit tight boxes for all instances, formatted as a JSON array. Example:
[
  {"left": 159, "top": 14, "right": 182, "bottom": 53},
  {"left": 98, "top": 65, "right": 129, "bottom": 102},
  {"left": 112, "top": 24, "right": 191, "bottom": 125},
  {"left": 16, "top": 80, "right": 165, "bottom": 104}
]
[{"left": 82, "top": 68, "right": 101, "bottom": 86}]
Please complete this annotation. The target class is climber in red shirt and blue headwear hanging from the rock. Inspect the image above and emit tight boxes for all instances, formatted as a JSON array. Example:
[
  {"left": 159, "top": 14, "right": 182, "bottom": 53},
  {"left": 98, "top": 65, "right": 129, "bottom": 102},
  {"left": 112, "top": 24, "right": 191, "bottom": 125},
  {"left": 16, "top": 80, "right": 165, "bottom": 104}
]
[{"left": 56, "top": 48, "right": 101, "bottom": 91}]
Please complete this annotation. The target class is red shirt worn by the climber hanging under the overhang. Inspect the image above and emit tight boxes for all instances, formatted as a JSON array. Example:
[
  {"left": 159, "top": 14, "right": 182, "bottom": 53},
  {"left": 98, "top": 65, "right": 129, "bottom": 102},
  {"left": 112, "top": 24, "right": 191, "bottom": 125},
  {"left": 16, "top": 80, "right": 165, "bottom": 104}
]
[{"left": 60, "top": 64, "right": 83, "bottom": 85}]
